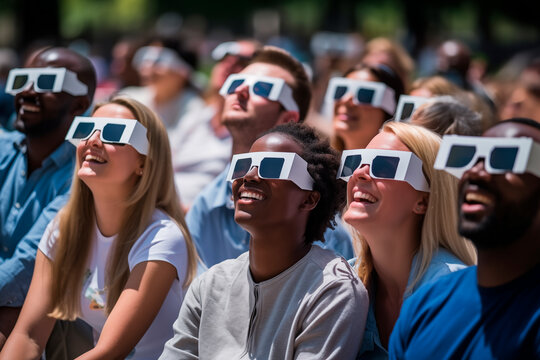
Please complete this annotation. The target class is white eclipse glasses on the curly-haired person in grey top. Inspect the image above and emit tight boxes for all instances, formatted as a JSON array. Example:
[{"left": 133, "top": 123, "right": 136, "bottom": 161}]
[{"left": 227, "top": 151, "right": 314, "bottom": 190}]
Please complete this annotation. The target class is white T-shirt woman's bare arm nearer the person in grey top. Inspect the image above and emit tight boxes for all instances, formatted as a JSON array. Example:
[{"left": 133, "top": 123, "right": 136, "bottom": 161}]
[{"left": 77, "top": 261, "right": 177, "bottom": 360}]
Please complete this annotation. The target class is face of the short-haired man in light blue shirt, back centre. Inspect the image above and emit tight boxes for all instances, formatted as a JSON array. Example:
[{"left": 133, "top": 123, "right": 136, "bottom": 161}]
[{"left": 222, "top": 63, "right": 295, "bottom": 139}]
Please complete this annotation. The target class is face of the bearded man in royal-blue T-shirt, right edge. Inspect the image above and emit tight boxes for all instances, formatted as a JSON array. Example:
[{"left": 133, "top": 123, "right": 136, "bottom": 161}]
[{"left": 459, "top": 123, "right": 540, "bottom": 250}]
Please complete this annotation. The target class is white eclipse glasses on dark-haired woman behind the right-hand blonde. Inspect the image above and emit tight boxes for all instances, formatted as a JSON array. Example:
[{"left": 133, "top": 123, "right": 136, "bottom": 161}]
[{"left": 325, "top": 77, "right": 396, "bottom": 114}]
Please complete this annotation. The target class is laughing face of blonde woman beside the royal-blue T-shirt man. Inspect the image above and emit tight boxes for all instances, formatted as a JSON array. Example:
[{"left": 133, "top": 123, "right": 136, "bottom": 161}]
[{"left": 343, "top": 131, "right": 425, "bottom": 233}]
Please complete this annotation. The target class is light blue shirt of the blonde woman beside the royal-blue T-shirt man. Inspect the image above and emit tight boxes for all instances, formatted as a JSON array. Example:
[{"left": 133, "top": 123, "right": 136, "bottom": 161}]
[{"left": 349, "top": 248, "right": 467, "bottom": 360}]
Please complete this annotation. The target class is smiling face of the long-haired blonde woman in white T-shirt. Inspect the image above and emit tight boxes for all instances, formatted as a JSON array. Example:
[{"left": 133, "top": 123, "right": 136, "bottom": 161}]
[{"left": 77, "top": 104, "right": 144, "bottom": 190}]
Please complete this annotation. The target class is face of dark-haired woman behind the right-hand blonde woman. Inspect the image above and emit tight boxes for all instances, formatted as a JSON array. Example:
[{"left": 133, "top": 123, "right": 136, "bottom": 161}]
[{"left": 333, "top": 69, "right": 385, "bottom": 149}]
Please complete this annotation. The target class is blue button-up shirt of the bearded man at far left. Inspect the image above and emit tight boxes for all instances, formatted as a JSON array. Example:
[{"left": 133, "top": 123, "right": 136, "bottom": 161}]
[{"left": 0, "top": 131, "right": 75, "bottom": 307}]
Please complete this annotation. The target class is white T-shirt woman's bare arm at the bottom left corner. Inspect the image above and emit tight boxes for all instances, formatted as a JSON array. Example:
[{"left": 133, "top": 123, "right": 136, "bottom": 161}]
[{"left": 0, "top": 251, "right": 56, "bottom": 360}]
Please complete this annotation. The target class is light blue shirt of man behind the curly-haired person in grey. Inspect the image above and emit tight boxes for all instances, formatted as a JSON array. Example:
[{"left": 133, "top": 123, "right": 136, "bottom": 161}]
[{"left": 186, "top": 167, "right": 353, "bottom": 267}]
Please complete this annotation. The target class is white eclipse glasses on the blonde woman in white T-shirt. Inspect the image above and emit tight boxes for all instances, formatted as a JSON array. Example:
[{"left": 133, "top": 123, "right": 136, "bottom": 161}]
[{"left": 66, "top": 116, "right": 148, "bottom": 155}]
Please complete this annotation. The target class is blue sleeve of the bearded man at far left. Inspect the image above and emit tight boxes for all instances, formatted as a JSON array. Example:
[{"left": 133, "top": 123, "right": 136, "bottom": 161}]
[{"left": 0, "top": 194, "right": 69, "bottom": 307}]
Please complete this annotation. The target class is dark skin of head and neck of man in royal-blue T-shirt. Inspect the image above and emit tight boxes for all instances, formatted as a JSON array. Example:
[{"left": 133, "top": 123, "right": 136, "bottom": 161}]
[{"left": 459, "top": 123, "right": 540, "bottom": 287}]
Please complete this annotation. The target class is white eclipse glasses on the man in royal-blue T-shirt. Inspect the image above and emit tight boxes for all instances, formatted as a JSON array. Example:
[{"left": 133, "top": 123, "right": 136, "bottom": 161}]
[{"left": 434, "top": 135, "right": 540, "bottom": 178}]
